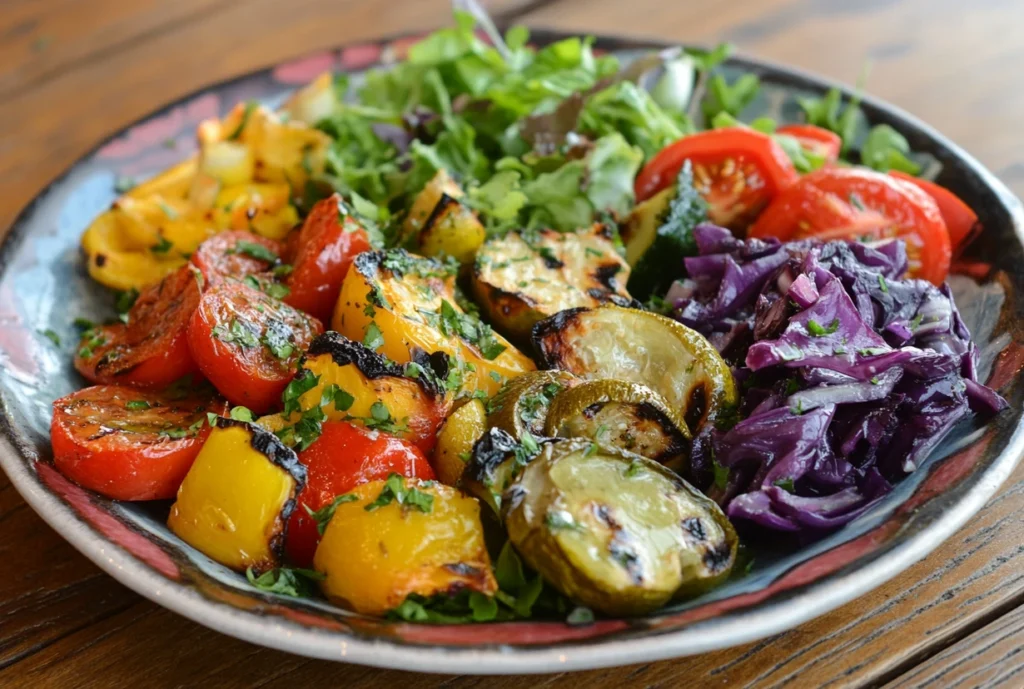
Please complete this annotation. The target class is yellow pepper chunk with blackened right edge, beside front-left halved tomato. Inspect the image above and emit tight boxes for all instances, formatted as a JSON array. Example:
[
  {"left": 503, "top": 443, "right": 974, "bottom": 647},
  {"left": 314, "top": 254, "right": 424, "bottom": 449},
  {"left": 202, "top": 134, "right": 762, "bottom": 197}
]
[{"left": 167, "top": 419, "right": 306, "bottom": 571}]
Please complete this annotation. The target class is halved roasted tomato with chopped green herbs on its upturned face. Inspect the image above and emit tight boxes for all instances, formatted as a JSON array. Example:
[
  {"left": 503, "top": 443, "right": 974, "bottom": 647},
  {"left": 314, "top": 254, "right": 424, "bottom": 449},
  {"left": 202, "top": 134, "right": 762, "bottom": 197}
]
[{"left": 188, "top": 281, "right": 324, "bottom": 414}]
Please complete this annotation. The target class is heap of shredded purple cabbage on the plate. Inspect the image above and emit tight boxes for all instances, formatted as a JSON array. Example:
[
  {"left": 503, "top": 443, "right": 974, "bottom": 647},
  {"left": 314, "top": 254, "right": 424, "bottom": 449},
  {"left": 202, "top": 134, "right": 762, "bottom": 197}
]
[{"left": 666, "top": 224, "right": 1007, "bottom": 535}]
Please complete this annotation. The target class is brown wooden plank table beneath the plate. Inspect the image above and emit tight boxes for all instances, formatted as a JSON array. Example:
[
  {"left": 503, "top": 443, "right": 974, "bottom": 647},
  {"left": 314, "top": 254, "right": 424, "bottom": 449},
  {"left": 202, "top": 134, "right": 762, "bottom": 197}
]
[{"left": 0, "top": 0, "right": 1024, "bottom": 689}]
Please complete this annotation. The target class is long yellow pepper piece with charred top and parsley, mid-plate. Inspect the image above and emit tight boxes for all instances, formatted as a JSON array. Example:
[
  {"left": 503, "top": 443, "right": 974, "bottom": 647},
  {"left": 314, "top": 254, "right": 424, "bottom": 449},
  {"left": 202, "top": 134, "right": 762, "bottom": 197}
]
[{"left": 332, "top": 250, "right": 535, "bottom": 396}]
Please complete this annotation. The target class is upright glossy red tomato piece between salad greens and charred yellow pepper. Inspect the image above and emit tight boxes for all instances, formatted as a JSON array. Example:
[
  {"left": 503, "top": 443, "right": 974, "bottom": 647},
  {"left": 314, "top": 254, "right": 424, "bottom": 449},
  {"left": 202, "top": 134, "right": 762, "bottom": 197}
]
[{"left": 285, "top": 193, "right": 371, "bottom": 320}]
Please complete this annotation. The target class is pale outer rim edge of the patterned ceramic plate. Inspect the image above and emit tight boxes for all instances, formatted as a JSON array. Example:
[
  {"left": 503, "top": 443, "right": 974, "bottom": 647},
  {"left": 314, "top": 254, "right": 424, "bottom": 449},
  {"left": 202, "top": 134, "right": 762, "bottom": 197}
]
[{"left": 6, "top": 28, "right": 1024, "bottom": 675}]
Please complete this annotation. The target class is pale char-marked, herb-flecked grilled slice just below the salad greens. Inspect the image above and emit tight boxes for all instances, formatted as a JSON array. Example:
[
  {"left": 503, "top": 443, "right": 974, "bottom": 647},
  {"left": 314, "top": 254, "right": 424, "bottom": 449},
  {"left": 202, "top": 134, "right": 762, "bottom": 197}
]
[{"left": 473, "top": 224, "right": 632, "bottom": 341}]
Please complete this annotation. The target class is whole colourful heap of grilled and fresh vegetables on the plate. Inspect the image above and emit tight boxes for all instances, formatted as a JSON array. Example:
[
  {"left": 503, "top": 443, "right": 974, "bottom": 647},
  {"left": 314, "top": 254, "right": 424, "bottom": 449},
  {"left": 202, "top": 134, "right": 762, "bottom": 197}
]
[{"left": 51, "top": 13, "right": 1007, "bottom": 623}]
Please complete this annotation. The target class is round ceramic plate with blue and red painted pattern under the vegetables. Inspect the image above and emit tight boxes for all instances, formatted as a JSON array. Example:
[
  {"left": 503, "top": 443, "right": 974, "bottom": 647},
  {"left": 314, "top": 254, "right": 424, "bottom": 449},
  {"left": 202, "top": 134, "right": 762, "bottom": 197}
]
[{"left": 0, "top": 33, "right": 1024, "bottom": 674}]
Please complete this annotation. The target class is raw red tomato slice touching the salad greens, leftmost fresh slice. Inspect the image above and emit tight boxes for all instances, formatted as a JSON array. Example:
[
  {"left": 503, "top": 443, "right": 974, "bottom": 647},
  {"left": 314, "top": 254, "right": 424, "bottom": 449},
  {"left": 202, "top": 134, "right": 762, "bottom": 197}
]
[{"left": 635, "top": 127, "right": 800, "bottom": 230}]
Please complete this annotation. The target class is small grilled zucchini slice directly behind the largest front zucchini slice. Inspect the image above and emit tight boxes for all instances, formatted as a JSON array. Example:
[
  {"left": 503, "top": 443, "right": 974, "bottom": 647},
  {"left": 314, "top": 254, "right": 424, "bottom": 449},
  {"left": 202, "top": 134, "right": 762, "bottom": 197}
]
[{"left": 544, "top": 381, "right": 689, "bottom": 464}]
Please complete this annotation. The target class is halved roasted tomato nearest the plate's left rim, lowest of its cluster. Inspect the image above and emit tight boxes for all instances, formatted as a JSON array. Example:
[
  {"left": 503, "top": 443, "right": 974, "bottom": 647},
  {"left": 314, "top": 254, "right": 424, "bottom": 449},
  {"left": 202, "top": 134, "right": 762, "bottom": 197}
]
[{"left": 50, "top": 385, "right": 226, "bottom": 500}]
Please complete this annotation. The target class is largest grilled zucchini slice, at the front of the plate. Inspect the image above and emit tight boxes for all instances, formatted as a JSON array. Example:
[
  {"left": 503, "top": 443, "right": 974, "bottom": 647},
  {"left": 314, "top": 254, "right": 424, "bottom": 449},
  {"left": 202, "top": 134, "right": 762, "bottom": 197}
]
[{"left": 504, "top": 438, "right": 737, "bottom": 615}]
